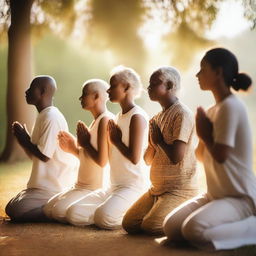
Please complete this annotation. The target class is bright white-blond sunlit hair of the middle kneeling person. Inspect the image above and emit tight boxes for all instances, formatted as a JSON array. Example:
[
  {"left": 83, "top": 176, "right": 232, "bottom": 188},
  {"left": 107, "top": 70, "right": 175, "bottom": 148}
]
[{"left": 110, "top": 65, "right": 142, "bottom": 98}]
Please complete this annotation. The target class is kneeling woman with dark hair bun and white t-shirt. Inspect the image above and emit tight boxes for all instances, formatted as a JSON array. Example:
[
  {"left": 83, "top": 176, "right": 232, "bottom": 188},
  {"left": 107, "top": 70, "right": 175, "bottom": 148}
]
[{"left": 164, "top": 48, "right": 256, "bottom": 250}]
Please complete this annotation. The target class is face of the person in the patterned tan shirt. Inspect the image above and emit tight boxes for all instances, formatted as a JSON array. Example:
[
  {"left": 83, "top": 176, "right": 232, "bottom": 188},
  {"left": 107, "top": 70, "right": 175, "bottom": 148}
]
[{"left": 147, "top": 72, "right": 166, "bottom": 101}]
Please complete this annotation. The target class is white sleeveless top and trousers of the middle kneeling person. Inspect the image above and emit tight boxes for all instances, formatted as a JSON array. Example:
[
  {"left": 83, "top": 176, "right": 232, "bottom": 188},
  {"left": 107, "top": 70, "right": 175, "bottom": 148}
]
[{"left": 66, "top": 106, "right": 148, "bottom": 229}]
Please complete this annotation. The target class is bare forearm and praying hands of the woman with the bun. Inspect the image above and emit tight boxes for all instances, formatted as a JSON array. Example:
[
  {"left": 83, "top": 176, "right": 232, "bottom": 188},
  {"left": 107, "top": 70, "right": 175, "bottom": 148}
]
[{"left": 196, "top": 108, "right": 231, "bottom": 163}]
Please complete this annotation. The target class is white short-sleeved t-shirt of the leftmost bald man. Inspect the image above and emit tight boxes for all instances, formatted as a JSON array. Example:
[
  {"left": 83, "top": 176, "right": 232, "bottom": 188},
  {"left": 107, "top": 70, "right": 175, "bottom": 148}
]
[{"left": 27, "top": 106, "right": 77, "bottom": 192}]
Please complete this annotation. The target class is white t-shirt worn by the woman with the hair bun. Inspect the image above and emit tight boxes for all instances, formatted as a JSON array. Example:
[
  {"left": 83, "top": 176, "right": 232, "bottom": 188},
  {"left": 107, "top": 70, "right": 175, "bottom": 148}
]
[{"left": 204, "top": 95, "right": 256, "bottom": 206}]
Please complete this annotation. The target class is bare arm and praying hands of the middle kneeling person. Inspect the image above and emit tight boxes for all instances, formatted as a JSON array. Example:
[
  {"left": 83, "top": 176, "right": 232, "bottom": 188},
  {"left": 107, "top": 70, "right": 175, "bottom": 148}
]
[{"left": 109, "top": 114, "right": 147, "bottom": 164}]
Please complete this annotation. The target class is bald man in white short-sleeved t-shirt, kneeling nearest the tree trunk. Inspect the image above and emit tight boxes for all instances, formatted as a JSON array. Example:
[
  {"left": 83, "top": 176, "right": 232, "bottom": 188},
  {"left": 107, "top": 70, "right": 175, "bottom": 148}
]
[{"left": 5, "top": 76, "right": 76, "bottom": 222}]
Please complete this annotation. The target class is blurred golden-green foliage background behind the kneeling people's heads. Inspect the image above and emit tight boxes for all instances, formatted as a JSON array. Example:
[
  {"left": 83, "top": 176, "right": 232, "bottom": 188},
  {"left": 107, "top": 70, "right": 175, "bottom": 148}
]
[{"left": 0, "top": 0, "right": 256, "bottom": 156}]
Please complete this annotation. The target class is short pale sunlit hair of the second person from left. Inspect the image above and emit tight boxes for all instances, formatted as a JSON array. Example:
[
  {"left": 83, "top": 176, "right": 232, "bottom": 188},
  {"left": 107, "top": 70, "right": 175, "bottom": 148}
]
[{"left": 82, "top": 79, "right": 109, "bottom": 101}]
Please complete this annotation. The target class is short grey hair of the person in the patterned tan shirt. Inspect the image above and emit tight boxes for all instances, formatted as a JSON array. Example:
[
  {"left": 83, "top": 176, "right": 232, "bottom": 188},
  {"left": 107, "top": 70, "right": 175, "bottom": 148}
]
[{"left": 154, "top": 66, "right": 180, "bottom": 92}]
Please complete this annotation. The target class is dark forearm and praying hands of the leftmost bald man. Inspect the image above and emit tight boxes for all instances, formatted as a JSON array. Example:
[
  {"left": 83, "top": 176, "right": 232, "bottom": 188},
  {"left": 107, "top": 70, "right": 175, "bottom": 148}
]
[{"left": 12, "top": 122, "right": 50, "bottom": 162}]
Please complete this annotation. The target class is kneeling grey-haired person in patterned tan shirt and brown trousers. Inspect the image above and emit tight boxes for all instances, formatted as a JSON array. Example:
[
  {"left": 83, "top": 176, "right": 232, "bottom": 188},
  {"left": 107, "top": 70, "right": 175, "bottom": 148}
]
[{"left": 122, "top": 67, "right": 197, "bottom": 235}]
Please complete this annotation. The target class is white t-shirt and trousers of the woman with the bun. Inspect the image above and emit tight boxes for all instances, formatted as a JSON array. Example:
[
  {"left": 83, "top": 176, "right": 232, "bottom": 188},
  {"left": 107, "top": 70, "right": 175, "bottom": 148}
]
[{"left": 164, "top": 95, "right": 256, "bottom": 249}]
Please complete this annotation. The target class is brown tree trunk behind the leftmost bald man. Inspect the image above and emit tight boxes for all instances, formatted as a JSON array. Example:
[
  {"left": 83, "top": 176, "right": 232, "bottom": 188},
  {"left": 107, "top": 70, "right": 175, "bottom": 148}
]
[{"left": 0, "top": 0, "right": 35, "bottom": 162}]
